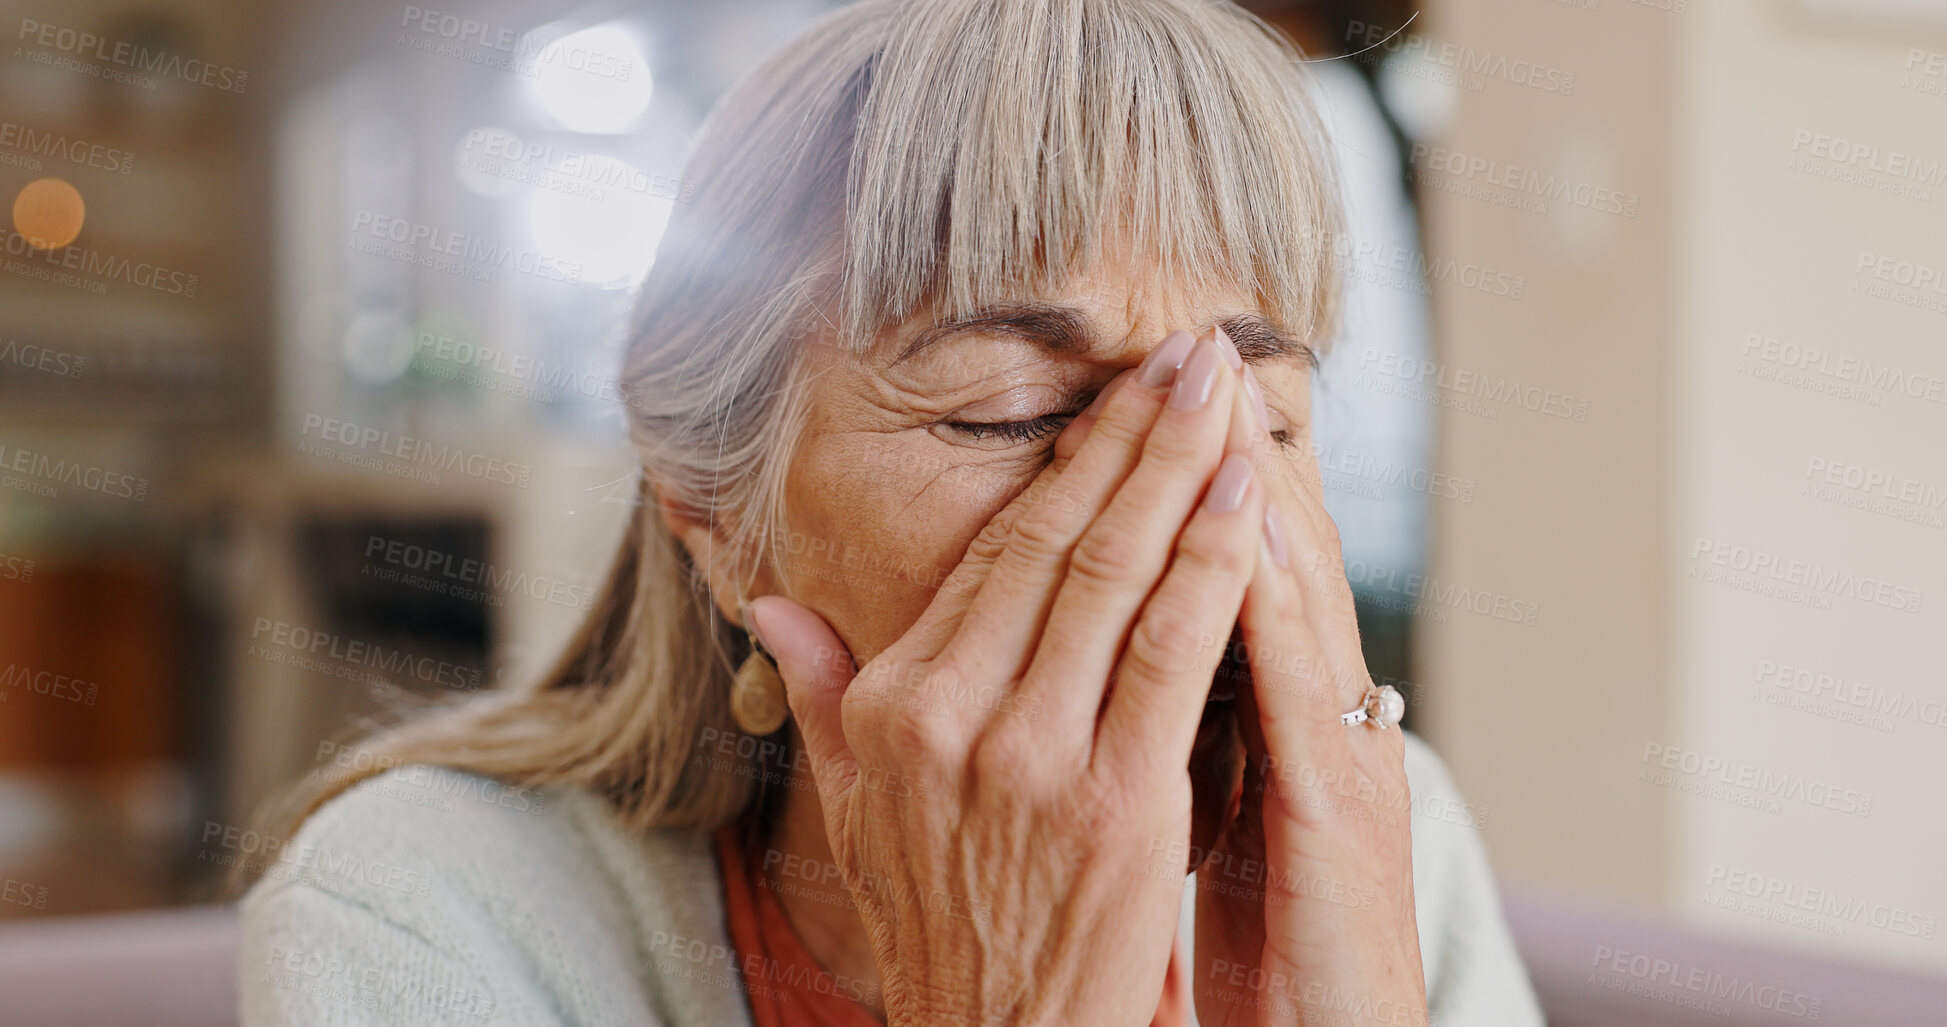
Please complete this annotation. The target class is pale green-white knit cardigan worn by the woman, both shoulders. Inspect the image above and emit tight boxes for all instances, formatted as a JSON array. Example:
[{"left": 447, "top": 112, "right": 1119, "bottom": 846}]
[{"left": 238, "top": 737, "right": 1542, "bottom": 1027}]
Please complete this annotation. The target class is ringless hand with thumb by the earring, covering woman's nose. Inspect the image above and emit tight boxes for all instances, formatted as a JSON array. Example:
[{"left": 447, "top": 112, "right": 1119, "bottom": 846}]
[{"left": 750, "top": 333, "right": 1266, "bottom": 1025}]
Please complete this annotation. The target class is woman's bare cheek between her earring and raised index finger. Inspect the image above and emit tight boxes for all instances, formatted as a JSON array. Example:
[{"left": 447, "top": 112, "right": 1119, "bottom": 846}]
[{"left": 783, "top": 433, "right": 1026, "bottom": 663}]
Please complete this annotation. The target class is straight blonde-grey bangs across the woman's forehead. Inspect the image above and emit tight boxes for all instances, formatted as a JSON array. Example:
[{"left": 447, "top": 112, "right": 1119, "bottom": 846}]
[{"left": 841, "top": 0, "right": 1338, "bottom": 345}]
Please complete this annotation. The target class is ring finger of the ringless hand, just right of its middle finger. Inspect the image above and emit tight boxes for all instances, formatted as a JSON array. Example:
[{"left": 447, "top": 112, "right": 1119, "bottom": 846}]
[{"left": 1098, "top": 354, "right": 1264, "bottom": 774}]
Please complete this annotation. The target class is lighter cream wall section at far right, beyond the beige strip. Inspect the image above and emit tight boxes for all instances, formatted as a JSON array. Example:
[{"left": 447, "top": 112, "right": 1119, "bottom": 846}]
[{"left": 1665, "top": 4, "right": 1947, "bottom": 972}]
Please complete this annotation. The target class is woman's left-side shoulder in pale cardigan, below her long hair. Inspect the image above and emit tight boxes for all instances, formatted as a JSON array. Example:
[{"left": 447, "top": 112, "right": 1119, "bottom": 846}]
[{"left": 239, "top": 764, "right": 711, "bottom": 1025}]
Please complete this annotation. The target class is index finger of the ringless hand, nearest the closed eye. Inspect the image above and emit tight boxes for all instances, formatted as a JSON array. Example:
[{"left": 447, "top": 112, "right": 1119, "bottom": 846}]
[{"left": 944, "top": 331, "right": 1195, "bottom": 680}]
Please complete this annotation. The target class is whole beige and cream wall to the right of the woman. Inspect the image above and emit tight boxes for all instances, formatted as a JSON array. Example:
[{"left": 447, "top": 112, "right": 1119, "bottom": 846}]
[{"left": 1417, "top": 0, "right": 1947, "bottom": 972}]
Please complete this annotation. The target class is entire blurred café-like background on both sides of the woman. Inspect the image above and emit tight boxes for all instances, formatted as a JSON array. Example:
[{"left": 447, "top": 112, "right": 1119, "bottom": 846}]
[{"left": 0, "top": 0, "right": 1947, "bottom": 1025}]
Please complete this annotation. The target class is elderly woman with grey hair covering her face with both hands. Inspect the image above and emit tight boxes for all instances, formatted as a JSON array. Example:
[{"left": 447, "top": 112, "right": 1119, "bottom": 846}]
[{"left": 241, "top": 0, "right": 1540, "bottom": 1027}]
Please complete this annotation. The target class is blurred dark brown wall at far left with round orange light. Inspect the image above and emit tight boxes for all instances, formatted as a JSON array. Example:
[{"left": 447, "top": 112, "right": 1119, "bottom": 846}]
[{"left": 0, "top": 0, "right": 271, "bottom": 923}]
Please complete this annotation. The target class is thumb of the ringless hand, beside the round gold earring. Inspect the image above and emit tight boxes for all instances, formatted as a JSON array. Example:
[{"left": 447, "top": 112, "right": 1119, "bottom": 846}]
[{"left": 746, "top": 596, "right": 859, "bottom": 817}]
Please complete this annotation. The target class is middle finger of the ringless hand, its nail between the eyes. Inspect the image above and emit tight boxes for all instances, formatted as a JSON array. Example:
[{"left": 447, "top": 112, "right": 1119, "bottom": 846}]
[{"left": 1022, "top": 333, "right": 1240, "bottom": 733}]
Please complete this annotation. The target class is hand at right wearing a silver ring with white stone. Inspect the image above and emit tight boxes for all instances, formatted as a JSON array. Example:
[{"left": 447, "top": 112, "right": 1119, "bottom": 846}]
[{"left": 1194, "top": 380, "right": 1427, "bottom": 1027}]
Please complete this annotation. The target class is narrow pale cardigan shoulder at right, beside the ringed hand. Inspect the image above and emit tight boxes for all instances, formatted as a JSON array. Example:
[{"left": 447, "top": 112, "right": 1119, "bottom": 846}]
[{"left": 1406, "top": 733, "right": 1542, "bottom": 1027}]
